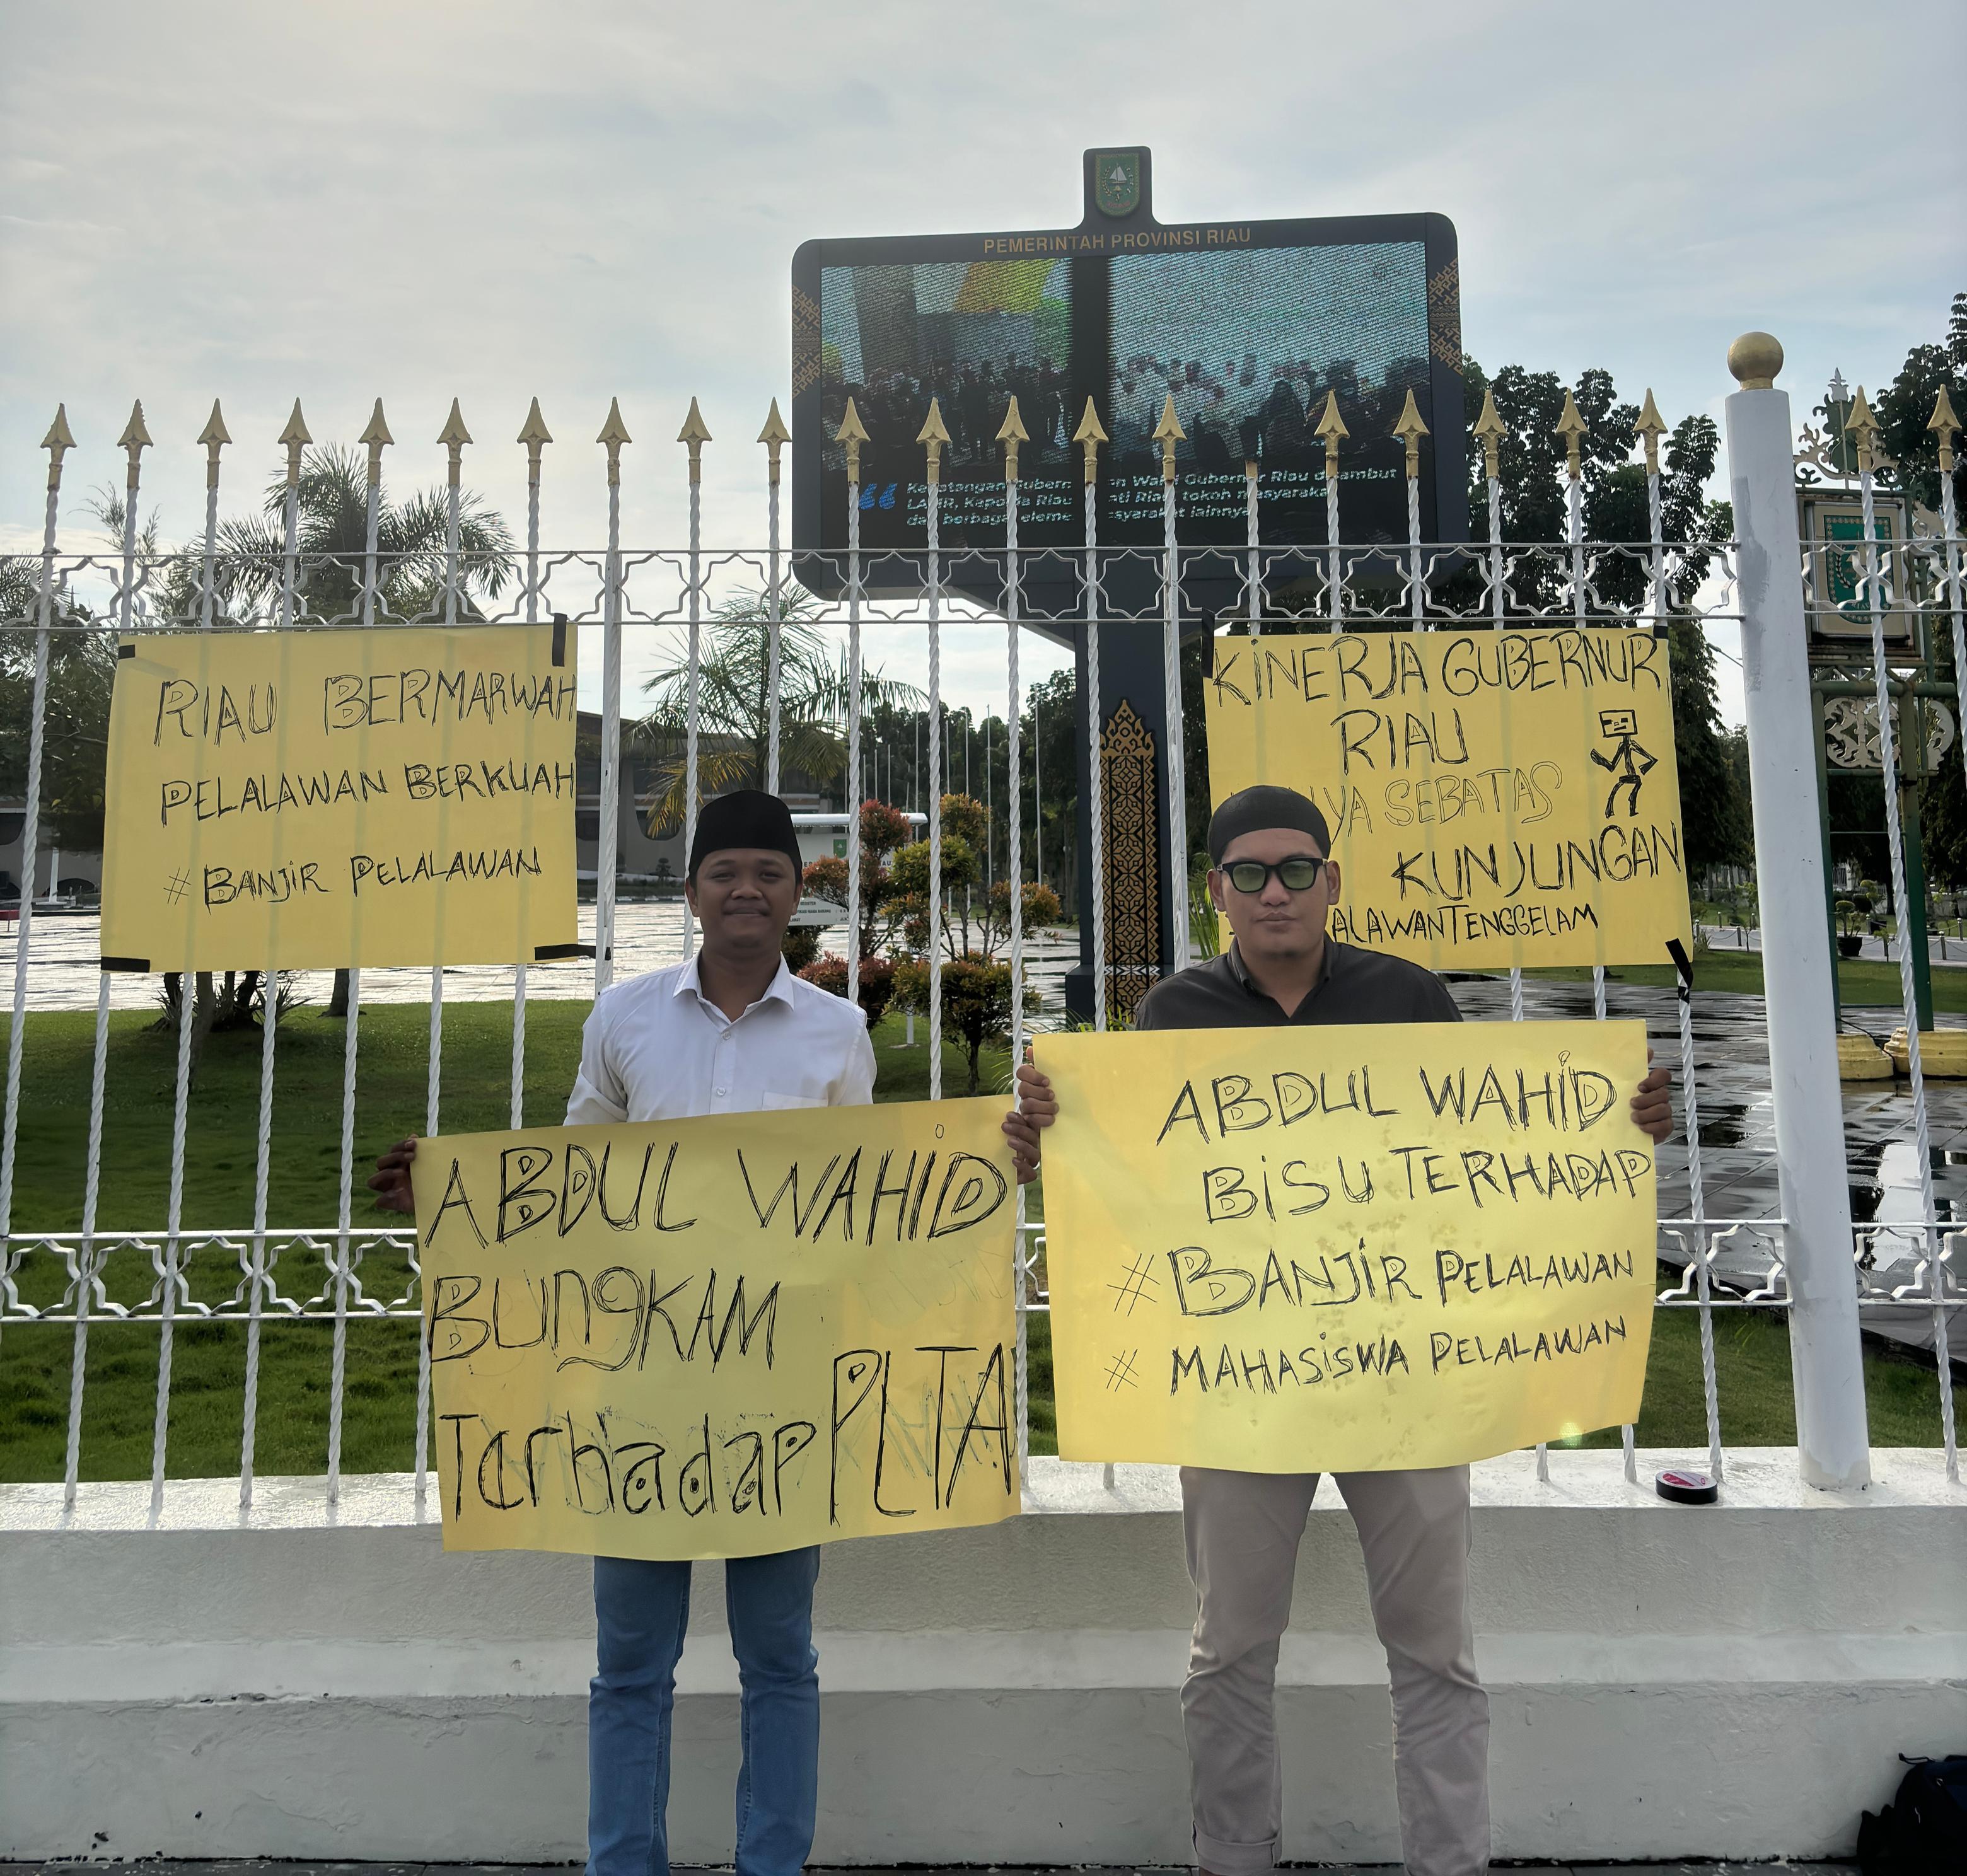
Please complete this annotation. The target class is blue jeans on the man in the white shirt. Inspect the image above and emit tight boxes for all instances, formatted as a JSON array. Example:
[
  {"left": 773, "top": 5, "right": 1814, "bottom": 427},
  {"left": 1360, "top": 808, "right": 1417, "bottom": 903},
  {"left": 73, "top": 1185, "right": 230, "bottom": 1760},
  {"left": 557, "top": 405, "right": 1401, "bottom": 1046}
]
[{"left": 588, "top": 1546, "right": 820, "bottom": 1876}]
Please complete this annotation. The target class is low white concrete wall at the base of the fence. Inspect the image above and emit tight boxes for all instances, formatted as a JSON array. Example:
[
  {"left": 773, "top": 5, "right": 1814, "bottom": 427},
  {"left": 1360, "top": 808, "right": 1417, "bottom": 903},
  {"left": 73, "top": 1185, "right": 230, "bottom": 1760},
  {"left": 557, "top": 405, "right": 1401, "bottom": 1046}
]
[{"left": 0, "top": 1449, "right": 1967, "bottom": 1864}]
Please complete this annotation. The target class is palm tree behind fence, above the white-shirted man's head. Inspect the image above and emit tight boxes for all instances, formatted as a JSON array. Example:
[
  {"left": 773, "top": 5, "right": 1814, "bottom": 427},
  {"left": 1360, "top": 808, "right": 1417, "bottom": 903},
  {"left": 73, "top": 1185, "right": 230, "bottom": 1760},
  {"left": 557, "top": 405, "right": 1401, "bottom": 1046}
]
[{"left": 634, "top": 586, "right": 920, "bottom": 828}]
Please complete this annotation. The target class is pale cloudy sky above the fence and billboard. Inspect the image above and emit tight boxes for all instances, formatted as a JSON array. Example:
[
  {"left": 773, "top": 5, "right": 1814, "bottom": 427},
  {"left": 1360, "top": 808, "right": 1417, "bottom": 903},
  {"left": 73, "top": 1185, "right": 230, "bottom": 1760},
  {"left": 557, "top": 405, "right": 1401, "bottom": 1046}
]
[{"left": 0, "top": 0, "right": 1967, "bottom": 723}]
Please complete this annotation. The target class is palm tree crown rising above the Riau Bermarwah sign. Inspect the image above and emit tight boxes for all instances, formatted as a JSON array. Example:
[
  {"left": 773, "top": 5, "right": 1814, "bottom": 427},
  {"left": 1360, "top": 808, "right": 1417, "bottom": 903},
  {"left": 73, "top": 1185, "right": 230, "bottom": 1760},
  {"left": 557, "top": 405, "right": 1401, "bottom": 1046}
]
[{"left": 210, "top": 444, "right": 513, "bottom": 622}]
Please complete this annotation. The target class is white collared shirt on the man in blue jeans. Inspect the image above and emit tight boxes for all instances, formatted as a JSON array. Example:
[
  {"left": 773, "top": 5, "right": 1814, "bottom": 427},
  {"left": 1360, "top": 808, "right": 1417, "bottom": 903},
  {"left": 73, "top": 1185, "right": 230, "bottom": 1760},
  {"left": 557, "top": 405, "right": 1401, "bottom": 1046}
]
[{"left": 567, "top": 956, "right": 873, "bottom": 1126}]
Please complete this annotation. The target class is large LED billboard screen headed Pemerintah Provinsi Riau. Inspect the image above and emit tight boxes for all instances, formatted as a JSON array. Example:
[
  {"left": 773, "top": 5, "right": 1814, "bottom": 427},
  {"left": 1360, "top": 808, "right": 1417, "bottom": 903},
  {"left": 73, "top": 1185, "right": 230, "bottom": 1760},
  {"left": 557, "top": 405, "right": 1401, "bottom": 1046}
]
[{"left": 792, "top": 153, "right": 1468, "bottom": 570}]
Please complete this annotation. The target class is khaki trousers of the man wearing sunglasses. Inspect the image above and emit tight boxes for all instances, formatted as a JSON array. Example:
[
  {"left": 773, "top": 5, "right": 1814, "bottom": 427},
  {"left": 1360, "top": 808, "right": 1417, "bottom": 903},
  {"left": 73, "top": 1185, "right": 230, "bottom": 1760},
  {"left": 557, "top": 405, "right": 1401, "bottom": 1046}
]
[{"left": 1182, "top": 1465, "right": 1489, "bottom": 1876}]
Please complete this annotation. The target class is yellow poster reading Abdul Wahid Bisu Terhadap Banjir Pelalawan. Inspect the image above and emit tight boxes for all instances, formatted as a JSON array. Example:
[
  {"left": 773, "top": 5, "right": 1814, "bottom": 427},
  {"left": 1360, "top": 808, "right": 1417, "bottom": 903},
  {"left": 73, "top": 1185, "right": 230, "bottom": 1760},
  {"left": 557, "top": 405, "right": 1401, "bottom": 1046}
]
[{"left": 1033, "top": 1022, "right": 1654, "bottom": 1473}]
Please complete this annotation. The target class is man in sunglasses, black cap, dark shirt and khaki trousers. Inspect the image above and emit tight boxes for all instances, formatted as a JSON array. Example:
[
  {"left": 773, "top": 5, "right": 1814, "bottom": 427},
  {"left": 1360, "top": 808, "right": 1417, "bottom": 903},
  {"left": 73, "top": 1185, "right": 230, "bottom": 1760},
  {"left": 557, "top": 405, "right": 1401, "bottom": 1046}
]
[{"left": 1003, "top": 787, "right": 1672, "bottom": 1876}]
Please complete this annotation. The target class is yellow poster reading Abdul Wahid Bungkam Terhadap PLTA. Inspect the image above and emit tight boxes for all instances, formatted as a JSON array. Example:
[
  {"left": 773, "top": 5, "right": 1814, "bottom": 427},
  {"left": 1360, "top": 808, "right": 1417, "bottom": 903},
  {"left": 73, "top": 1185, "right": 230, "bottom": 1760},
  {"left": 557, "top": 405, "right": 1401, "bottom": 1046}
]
[{"left": 415, "top": 1101, "right": 1019, "bottom": 1558}]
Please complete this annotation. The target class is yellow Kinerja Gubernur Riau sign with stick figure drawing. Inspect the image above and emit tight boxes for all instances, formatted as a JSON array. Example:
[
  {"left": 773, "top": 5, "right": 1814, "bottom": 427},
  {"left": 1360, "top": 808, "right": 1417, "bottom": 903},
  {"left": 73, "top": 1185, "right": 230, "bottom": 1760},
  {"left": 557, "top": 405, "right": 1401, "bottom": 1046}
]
[{"left": 1204, "top": 629, "right": 1691, "bottom": 970}]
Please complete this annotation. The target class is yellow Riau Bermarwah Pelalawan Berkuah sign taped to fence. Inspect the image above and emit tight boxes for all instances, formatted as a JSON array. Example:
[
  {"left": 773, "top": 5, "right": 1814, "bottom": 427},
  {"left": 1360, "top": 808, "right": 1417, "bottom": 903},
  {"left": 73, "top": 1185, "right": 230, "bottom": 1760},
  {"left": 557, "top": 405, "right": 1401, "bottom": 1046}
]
[{"left": 102, "top": 625, "right": 578, "bottom": 971}]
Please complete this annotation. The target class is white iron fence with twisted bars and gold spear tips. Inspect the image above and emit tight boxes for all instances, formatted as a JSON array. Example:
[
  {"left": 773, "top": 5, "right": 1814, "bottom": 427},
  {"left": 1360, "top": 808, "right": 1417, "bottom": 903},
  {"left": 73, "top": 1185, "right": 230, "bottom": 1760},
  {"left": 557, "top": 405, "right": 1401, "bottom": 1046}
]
[{"left": 0, "top": 357, "right": 1967, "bottom": 1502}]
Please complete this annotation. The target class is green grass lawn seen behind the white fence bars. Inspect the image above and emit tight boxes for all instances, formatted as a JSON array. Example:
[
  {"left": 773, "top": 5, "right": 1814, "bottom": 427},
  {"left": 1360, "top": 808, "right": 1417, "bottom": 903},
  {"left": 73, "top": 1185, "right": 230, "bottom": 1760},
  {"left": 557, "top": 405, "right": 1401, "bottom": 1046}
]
[{"left": 0, "top": 995, "right": 1939, "bottom": 1481}]
